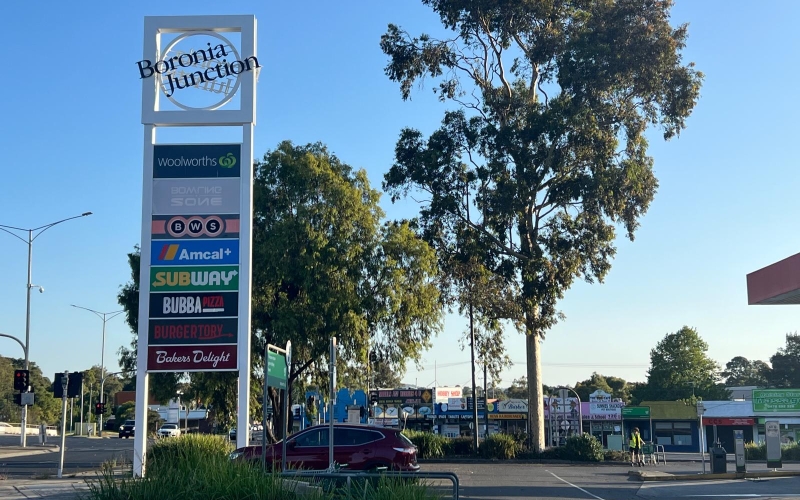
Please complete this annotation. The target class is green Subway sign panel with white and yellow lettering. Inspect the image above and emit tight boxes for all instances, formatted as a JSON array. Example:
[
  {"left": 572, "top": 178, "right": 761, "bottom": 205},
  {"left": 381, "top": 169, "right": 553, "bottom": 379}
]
[{"left": 150, "top": 266, "right": 239, "bottom": 292}]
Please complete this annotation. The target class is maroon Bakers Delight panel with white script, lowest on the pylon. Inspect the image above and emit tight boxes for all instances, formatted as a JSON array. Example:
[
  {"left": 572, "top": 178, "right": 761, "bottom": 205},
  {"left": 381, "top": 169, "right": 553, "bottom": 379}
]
[{"left": 147, "top": 344, "right": 238, "bottom": 372}]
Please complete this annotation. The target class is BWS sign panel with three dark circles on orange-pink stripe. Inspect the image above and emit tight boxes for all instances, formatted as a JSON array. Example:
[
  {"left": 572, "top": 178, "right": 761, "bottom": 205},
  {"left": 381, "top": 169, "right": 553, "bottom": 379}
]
[{"left": 151, "top": 215, "right": 239, "bottom": 240}]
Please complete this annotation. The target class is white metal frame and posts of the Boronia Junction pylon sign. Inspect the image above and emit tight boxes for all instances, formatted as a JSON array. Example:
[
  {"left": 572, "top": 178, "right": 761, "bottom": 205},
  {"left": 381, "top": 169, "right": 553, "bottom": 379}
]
[{"left": 136, "top": 15, "right": 258, "bottom": 477}]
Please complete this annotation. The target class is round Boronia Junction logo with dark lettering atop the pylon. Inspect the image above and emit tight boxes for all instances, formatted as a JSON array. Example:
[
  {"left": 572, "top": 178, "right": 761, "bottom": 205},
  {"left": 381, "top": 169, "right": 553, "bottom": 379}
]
[{"left": 136, "top": 31, "right": 261, "bottom": 110}]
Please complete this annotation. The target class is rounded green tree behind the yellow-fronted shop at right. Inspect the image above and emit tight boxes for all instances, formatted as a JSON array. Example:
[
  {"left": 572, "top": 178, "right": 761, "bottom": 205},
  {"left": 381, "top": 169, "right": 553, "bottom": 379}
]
[{"left": 638, "top": 326, "right": 729, "bottom": 401}]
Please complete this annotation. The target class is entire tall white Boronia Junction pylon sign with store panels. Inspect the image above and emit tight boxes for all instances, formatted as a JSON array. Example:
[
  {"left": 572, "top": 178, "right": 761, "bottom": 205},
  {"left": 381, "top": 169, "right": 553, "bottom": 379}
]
[{"left": 131, "top": 15, "right": 255, "bottom": 475}]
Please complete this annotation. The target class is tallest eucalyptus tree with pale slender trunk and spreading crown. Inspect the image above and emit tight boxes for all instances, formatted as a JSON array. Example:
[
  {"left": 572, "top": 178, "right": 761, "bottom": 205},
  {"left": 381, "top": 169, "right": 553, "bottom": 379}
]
[{"left": 381, "top": 0, "right": 702, "bottom": 450}]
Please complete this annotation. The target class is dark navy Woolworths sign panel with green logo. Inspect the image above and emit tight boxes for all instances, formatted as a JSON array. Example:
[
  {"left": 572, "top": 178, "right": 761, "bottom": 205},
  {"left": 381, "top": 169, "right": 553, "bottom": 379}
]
[{"left": 153, "top": 144, "right": 242, "bottom": 179}]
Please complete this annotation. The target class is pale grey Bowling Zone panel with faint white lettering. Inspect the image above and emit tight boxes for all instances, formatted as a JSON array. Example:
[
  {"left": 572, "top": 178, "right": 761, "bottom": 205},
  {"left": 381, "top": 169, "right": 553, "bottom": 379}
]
[{"left": 153, "top": 178, "right": 240, "bottom": 215}]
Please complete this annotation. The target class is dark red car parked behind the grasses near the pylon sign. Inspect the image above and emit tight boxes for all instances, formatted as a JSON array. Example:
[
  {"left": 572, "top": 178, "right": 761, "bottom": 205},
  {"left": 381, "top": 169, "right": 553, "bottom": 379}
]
[{"left": 230, "top": 424, "right": 419, "bottom": 472}]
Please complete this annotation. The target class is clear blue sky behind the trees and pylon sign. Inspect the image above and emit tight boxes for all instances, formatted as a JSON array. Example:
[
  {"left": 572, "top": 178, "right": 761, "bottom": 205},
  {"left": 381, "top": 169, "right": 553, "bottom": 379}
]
[{"left": 0, "top": 0, "right": 800, "bottom": 385}]
